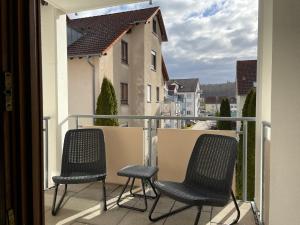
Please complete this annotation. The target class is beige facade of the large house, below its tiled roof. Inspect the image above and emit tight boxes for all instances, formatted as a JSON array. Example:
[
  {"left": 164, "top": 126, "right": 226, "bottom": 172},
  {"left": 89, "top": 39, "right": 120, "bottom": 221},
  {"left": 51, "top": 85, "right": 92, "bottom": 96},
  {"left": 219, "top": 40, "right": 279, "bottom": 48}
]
[{"left": 68, "top": 8, "right": 166, "bottom": 125}]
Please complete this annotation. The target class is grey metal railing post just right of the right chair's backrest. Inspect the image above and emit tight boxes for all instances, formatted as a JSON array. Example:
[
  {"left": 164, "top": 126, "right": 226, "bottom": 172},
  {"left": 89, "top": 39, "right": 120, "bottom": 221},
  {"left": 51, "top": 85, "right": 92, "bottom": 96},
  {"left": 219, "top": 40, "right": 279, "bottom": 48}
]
[{"left": 243, "top": 120, "right": 248, "bottom": 201}]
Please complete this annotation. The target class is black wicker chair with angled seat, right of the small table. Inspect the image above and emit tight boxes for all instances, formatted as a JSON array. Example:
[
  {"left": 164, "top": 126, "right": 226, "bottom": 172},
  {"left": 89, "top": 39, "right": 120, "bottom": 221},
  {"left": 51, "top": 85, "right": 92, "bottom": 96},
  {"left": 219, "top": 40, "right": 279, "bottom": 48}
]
[{"left": 149, "top": 134, "right": 240, "bottom": 225}]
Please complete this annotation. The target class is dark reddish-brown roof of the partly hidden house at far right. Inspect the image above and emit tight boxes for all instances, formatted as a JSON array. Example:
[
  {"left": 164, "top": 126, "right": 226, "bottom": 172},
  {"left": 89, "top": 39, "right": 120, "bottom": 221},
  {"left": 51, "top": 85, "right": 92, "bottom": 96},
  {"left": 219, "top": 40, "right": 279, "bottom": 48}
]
[{"left": 236, "top": 60, "right": 257, "bottom": 95}]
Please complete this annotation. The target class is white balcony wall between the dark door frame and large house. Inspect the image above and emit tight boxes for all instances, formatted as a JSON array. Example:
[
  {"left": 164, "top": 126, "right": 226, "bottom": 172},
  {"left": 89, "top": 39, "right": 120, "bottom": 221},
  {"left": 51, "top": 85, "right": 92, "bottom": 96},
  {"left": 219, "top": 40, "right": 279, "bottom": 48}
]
[{"left": 41, "top": 4, "right": 69, "bottom": 185}]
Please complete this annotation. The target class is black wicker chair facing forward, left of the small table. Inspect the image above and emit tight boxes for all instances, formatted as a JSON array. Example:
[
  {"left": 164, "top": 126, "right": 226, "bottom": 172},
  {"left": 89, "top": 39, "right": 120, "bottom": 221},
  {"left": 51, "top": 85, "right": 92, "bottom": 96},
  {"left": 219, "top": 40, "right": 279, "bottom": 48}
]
[{"left": 52, "top": 129, "right": 107, "bottom": 215}]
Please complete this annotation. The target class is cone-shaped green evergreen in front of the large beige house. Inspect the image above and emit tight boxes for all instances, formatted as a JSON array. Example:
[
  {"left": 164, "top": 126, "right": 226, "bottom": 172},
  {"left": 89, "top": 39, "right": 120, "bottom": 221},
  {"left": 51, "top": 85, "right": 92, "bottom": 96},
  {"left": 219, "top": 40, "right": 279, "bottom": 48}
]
[{"left": 95, "top": 78, "right": 119, "bottom": 126}]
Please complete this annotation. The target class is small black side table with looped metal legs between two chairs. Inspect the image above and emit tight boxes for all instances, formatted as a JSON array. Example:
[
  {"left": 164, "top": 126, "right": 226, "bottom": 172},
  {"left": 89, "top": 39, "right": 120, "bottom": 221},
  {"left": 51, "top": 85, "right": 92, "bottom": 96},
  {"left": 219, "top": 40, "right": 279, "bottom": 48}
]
[{"left": 117, "top": 165, "right": 158, "bottom": 212}]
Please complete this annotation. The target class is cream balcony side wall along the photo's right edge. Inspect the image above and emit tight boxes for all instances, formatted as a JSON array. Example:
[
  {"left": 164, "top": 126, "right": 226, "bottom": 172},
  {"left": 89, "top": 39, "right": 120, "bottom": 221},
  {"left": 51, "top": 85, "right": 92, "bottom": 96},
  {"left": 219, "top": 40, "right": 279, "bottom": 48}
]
[{"left": 255, "top": 0, "right": 300, "bottom": 225}]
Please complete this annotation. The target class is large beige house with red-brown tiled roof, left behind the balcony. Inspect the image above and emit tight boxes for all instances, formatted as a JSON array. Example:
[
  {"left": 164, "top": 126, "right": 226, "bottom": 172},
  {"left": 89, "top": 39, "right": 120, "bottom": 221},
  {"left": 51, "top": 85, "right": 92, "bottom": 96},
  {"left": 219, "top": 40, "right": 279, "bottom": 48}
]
[{"left": 68, "top": 7, "right": 168, "bottom": 126}]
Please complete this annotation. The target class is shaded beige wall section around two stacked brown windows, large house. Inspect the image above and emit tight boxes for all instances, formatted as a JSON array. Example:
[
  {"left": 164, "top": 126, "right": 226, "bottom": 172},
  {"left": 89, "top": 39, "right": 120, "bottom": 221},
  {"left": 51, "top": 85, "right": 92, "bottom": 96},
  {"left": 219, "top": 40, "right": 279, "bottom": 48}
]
[{"left": 112, "top": 24, "right": 144, "bottom": 118}]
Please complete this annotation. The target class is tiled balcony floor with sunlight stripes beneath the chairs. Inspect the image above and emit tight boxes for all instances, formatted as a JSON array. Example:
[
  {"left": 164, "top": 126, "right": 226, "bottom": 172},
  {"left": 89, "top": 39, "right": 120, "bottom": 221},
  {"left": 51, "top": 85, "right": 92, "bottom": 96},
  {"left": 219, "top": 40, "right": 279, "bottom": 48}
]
[{"left": 45, "top": 183, "right": 255, "bottom": 225}]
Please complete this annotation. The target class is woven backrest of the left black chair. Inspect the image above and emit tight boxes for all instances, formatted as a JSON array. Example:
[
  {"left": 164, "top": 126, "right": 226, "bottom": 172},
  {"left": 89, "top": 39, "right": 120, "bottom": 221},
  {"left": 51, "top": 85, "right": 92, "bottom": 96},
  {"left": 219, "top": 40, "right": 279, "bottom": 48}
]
[{"left": 61, "top": 129, "right": 106, "bottom": 176}]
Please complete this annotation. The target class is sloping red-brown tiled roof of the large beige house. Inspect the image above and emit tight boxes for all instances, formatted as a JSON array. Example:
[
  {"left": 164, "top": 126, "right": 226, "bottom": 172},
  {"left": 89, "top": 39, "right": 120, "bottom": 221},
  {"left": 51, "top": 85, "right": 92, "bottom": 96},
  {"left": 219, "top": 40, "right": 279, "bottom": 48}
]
[{"left": 68, "top": 7, "right": 168, "bottom": 57}]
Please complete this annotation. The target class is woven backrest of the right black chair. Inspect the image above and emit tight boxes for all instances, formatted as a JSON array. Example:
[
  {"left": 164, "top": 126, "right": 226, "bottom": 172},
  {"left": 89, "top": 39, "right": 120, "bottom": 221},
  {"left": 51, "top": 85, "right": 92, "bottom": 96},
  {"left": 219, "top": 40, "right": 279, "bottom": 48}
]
[{"left": 184, "top": 134, "right": 237, "bottom": 194}]
